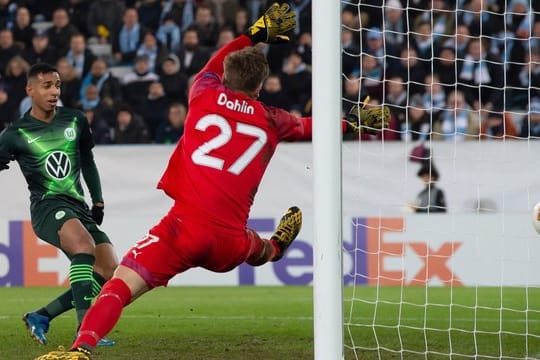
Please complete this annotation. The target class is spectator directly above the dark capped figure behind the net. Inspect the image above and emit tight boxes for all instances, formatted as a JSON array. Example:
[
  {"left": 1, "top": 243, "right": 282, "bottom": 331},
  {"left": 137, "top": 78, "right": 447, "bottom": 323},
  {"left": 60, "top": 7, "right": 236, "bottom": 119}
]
[{"left": 401, "top": 94, "right": 431, "bottom": 142}]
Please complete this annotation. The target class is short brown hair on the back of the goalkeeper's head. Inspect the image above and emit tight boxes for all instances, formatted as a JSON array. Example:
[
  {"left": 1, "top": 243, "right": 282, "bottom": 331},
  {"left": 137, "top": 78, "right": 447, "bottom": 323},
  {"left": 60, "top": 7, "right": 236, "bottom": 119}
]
[{"left": 223, "top": 47, "right": 270, "bottom": 95}]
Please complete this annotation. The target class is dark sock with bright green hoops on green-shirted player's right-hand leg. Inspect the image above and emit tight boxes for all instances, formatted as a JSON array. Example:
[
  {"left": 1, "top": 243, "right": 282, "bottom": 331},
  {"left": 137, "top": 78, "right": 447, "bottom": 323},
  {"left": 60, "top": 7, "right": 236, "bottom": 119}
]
[{"left": 69, "top": 254, "right": 95, "bottom": 324}]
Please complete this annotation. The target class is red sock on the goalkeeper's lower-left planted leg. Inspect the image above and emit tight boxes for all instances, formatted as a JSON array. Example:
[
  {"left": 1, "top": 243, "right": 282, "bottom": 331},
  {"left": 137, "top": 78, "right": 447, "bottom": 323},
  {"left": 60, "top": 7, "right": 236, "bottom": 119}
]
[{"left": 71, "top": 278, "right": 131, "bottom": 349}]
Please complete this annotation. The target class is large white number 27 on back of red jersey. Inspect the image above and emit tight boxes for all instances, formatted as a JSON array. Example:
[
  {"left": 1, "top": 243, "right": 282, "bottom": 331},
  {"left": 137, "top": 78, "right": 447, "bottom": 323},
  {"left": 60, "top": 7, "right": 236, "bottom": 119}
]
[{"left": 191, "top": 114, "right": 267, "bottom": 175}]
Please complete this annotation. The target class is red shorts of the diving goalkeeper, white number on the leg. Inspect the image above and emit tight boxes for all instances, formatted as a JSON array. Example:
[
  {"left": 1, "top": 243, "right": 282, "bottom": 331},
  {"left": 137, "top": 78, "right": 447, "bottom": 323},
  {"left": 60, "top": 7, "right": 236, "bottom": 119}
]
[{"left": 121, "top": 210, "right": 263, "bottom": 288}]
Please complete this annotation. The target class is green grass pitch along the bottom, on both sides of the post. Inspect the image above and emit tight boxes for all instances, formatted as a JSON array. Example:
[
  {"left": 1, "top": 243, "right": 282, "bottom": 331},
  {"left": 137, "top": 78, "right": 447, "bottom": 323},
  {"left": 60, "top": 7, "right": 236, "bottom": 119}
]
[{"left": 0, "top": 287, "right": 540, "bottom": 360}]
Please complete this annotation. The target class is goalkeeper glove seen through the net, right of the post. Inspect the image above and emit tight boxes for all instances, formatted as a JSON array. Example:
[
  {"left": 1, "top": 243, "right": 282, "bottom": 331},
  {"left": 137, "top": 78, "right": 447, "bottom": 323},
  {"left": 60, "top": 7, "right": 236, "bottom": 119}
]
[{"left": 346, "top": 96, "right": 390, "bottom": 135}]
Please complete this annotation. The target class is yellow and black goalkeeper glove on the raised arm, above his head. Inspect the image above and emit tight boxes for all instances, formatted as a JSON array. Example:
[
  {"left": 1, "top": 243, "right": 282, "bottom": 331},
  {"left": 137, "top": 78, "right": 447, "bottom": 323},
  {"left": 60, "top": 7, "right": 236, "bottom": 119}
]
[{"left": 246, "top": 3, "right": 296, "bottom": 44}]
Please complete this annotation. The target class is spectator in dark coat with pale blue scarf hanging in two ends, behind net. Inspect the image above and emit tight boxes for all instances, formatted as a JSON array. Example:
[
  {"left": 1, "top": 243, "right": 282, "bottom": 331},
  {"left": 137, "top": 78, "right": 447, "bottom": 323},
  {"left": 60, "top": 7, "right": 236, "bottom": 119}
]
[{"left": 458, "top": 38, "right": 504, "bottom": 110}]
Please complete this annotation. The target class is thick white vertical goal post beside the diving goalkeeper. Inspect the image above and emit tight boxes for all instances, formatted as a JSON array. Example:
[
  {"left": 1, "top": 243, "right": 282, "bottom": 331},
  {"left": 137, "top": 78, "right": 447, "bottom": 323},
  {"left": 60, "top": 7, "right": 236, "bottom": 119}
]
[{"left": 312, "top": 0, "right": 343, "bottom": 360}]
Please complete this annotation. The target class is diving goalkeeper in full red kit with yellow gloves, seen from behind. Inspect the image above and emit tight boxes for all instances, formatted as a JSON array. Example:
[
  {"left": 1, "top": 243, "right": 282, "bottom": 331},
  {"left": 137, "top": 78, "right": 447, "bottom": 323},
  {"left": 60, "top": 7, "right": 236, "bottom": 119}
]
[{"left": 34, "top": 3, "right": 389, "bottom": 360}]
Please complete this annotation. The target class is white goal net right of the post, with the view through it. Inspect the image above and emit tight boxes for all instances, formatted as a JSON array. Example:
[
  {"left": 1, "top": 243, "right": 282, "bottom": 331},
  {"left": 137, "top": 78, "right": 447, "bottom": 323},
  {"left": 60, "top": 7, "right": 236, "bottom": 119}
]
[{"left": 340, "top": 0, "right": 540, "bottom": 359}]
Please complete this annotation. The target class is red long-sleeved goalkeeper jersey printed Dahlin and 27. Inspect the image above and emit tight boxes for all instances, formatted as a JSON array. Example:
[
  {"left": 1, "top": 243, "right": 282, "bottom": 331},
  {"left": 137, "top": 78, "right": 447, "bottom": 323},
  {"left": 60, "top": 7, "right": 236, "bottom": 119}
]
[{"left": 158, "top": 35, "right": 311, "bottom": 228}]
